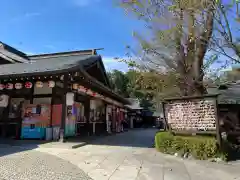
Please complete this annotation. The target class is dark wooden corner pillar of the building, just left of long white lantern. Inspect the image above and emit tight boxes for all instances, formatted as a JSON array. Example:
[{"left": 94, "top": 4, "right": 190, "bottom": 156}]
[{"left": 59, "top": 74, "right": 68, "bottom": 142}]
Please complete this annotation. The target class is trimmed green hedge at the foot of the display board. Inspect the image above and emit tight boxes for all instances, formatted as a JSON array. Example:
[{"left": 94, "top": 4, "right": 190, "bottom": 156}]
[{"left": 155, "top": 132, "right": 225, "bottom": 160}]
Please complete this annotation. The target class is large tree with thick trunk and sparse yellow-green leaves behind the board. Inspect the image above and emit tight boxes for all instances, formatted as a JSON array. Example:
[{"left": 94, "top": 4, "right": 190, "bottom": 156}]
[{"left": 118, "top": 0, "right": 218, "bottom": 95}]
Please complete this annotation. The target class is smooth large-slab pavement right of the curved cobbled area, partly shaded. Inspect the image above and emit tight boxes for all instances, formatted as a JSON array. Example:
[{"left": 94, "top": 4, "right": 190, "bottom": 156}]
[{"left": 36, "top": 129, "right": 240, "bottom": 180}]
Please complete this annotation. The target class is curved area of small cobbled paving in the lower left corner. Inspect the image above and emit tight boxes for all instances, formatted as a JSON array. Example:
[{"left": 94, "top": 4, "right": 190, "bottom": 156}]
[{"left": 0, "top": 145, "right": 91, "bottom": 180}]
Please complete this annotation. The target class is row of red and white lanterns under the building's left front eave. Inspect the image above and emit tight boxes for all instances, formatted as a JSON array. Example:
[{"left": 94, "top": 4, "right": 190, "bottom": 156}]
[{"left": 0, "top": 81, "right": 55, "bottom": 90}]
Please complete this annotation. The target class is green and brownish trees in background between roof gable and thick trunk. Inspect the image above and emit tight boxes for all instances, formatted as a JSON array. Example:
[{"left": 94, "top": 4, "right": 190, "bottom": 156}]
[{"left": 108, "top": 70, "right": 179, "bottom": 110}]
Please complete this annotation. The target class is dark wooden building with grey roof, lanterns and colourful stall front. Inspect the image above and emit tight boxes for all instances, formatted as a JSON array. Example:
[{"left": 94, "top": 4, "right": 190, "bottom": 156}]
[{"left": 0, "top": 56, "right": 127, "bottom": 141}]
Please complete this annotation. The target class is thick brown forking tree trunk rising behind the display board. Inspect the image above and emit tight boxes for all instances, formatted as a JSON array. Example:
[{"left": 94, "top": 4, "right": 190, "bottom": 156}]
[{"left": 177, "top": 3, "right": 214, "bottom": 96}]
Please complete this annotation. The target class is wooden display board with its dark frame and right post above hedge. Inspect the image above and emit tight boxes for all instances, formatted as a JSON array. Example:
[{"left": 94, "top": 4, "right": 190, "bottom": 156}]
[{"left": 163, "top": 95, "right": 222, "bottom": 147}]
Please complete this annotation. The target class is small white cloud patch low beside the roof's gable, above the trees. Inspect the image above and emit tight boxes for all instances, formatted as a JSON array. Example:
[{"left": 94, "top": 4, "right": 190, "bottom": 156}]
[{"left": 102, "top": 56, "right": 128, "bottom": 72}]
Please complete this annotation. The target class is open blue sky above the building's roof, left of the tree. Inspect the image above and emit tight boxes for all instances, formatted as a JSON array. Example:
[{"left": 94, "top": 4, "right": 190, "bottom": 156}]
[{"left": 0, "top": 0, "right": 142, "bottom": 70}]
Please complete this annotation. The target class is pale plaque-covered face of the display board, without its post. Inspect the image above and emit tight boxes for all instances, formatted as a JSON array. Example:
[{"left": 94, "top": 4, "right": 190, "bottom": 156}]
[{"left": 165, "top": 99, "right": 217, "bottom": 131}]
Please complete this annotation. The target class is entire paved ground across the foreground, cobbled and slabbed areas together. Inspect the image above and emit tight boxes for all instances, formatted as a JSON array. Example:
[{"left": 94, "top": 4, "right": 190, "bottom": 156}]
[{"left": 0, "top": 129, "right": 240, "bottom": 180}]
